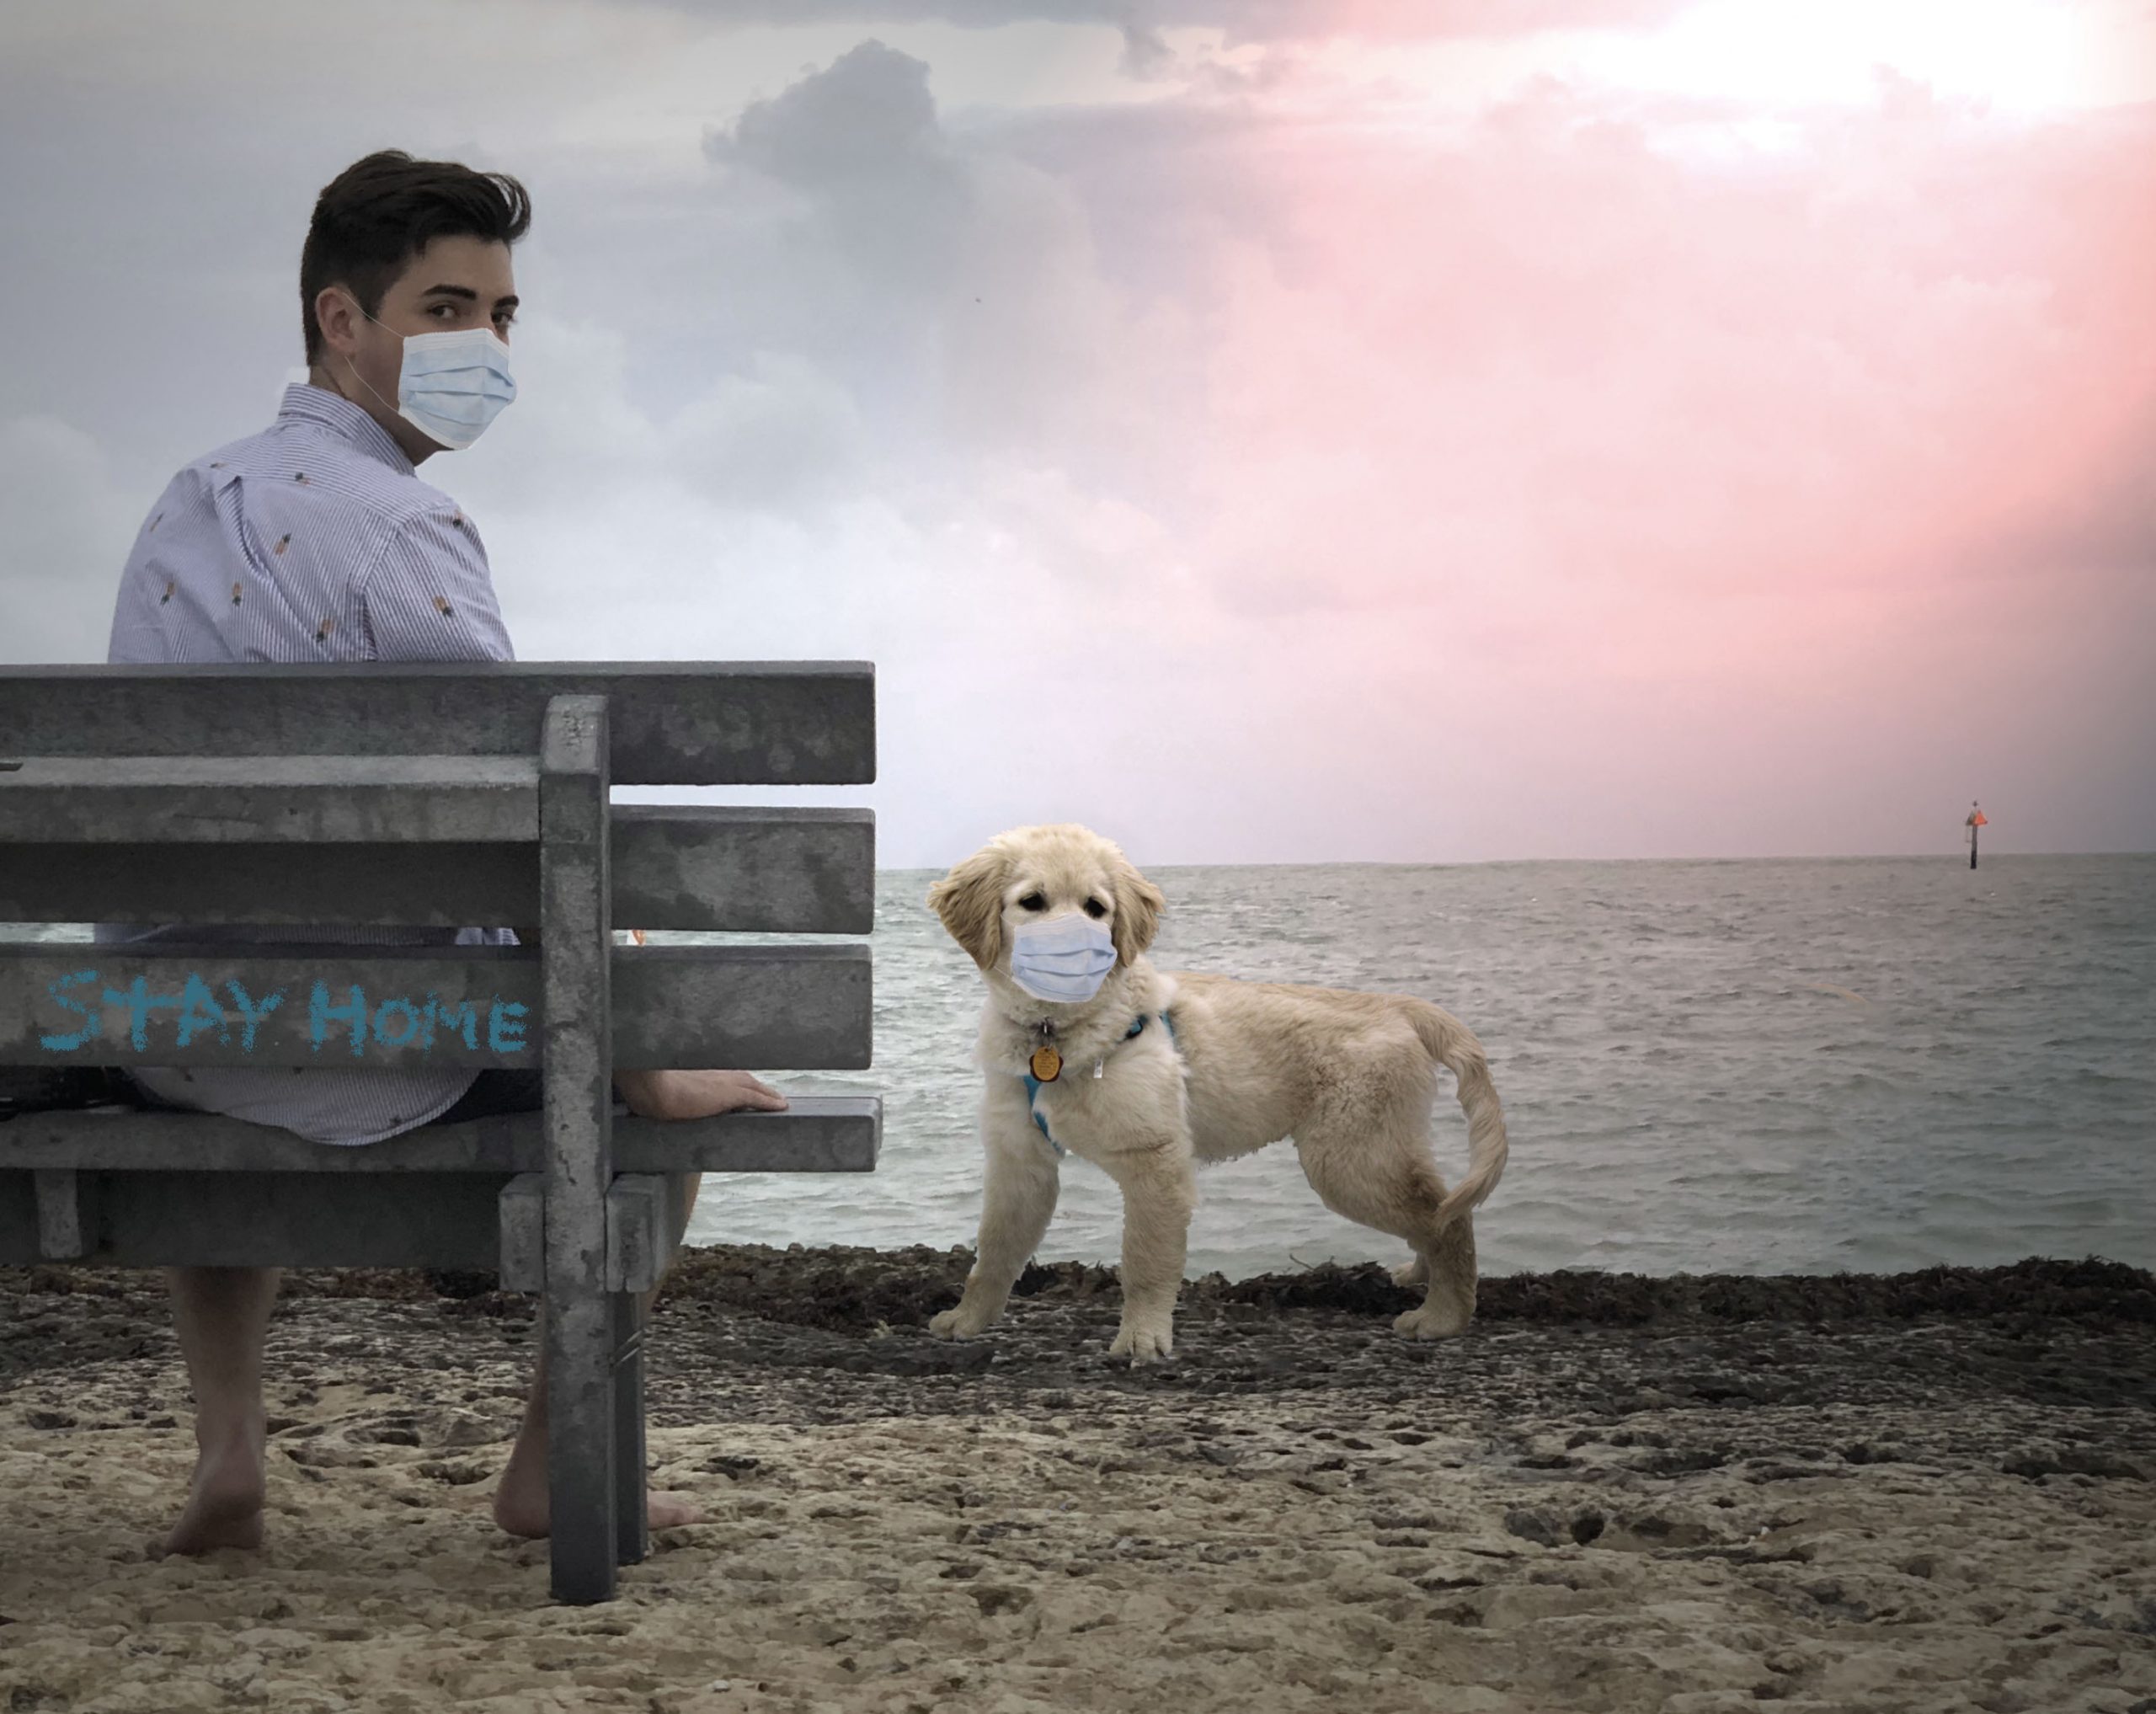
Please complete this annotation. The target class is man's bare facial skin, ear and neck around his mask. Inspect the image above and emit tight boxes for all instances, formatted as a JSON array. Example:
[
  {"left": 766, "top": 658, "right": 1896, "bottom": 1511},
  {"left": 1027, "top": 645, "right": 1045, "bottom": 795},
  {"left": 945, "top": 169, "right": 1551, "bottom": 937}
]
[{"left": 315, "top": 238, "right": 517, "bottom": 463}]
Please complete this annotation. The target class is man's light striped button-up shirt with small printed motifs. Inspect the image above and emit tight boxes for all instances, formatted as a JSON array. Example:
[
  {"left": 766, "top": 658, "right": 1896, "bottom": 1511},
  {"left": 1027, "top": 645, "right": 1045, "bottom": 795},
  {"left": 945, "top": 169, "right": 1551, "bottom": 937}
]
[{"left": 97, "top": 386, "right": 515, "bottom": 1143}]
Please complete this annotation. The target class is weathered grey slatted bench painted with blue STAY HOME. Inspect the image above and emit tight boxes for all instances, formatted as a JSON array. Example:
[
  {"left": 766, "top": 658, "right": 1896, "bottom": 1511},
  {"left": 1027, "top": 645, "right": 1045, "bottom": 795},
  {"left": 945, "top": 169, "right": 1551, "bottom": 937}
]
[{"left": 0, "top": 662, "right": 882, "bottom": 1602}]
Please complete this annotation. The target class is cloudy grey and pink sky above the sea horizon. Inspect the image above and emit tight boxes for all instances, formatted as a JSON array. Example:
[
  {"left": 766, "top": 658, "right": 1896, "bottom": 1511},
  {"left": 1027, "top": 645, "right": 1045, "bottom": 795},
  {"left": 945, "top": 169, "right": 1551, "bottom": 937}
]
[{"left": 0, "top": 0, "right": 2156, "bottom": 867}]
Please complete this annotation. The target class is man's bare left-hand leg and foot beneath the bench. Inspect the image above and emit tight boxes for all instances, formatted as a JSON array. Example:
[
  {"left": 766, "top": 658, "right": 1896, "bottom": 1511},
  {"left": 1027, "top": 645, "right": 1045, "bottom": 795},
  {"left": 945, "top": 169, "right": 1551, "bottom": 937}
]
[{"left": 164, "top": 1268, "right": 278, "bottom": 1552}]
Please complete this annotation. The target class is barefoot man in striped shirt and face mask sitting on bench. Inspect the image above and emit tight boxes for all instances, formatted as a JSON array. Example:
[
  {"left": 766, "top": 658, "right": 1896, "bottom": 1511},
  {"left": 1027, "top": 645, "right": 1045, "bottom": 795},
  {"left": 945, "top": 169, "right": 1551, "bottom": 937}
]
[{"left": 99, "top": 151, "right": 785, "bottom": 1552}]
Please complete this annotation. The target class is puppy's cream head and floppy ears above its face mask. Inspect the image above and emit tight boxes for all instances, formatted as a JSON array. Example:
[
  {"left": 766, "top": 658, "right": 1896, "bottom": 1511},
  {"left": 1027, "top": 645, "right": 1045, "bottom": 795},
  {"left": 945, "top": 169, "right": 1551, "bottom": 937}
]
[{"left": 929, "top": 821, "right": 1166, "bottom": 987}]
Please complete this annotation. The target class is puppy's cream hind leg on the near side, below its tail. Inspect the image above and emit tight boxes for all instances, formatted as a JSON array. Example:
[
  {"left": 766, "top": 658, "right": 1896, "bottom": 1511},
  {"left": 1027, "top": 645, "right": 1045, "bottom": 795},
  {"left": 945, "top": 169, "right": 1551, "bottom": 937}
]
[{"left": 1296, "top": 1114, "right": 1475, "bottom": 1339}]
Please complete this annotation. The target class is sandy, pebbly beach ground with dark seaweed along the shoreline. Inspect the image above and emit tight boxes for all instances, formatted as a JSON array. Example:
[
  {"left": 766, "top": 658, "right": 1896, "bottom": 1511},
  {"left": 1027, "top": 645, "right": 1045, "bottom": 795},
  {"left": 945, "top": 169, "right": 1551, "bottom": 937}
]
[{"left": 0, "top": 1248, "right": 2156, "bottom": 1714}]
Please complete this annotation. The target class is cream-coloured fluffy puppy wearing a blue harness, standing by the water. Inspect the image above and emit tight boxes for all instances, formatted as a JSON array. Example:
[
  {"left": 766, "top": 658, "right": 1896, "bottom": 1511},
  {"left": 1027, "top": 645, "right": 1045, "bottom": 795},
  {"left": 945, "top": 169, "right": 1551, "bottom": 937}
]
[{"left": 929, "top": 825, "right": 1505, "bottom": 1363}]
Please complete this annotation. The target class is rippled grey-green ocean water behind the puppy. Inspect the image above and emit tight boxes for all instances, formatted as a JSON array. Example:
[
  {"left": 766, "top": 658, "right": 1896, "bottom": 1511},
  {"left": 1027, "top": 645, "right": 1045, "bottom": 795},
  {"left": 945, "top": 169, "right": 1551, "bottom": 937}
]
[{"left": 694, "top": 850, "right": 2156, "bottom": 1279}]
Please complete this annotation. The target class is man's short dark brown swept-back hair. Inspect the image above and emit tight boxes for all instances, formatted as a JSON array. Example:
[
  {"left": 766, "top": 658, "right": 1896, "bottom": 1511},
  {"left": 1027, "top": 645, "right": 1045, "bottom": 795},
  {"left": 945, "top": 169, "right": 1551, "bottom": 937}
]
[{"left": 300, "top": 149, "right": 532, "bottom": 365}]
